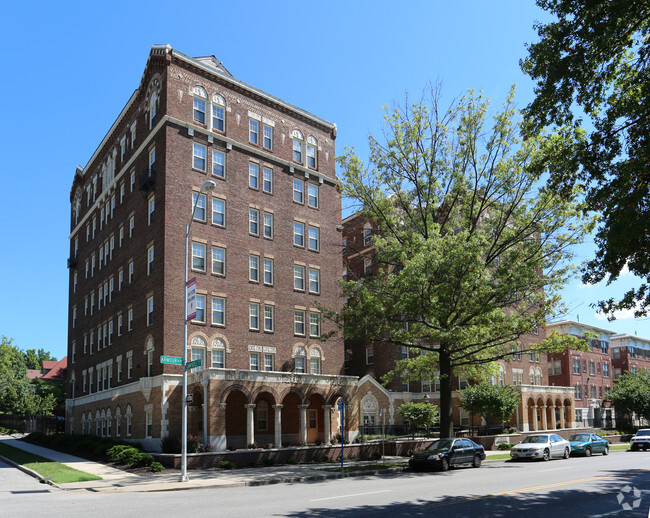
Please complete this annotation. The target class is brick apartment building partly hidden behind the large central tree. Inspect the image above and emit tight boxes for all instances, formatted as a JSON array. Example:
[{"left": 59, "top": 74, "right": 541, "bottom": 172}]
[{"left": 343, "top": 214, "right": 574, "bottom": 431}]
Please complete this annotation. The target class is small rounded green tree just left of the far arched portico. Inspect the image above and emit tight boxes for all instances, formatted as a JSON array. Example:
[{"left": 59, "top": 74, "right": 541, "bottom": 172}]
[{"left": 460, "top": 381, "right": 521, "bottom": 433}]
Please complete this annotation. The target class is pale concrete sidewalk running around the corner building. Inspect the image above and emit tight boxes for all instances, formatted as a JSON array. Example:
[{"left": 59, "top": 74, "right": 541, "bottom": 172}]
[{"left": 0, "top": 436, "right": 520, "bottom": 493}]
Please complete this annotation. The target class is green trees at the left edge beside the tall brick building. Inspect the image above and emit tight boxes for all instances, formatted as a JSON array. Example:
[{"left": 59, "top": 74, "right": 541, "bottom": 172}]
[{"left": 0, "top": 336, "right": 56, "bottom": 414}]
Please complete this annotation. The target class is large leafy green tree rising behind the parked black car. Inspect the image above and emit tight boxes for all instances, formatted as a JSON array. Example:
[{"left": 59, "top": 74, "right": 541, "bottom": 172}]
[{"left": 339, "top": 89, "right": 591, "bottom": 437}]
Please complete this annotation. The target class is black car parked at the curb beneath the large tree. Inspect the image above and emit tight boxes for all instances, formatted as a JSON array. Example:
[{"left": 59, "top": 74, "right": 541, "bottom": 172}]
[{"left": 409, "top": 439, "right": 485, "bottom": 471}]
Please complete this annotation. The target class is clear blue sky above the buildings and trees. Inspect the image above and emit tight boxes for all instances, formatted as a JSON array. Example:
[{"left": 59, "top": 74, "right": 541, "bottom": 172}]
[{"left": 0, "top": 0, "right": 650, "bottom": 359}]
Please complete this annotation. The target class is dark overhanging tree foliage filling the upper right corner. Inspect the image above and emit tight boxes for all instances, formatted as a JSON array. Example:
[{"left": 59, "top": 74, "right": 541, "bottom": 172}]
[{"left": 521, "top": 0, "right": 650, "bottom": 316}]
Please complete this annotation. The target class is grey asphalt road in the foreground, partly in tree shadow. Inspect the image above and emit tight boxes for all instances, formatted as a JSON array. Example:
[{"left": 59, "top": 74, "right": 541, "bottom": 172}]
[{"left": 0, "top": 452, "right": 650, "bottom": 518}]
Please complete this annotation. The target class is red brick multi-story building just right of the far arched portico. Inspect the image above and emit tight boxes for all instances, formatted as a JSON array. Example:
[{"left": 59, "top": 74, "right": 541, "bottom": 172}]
[{"left": 546, "top": 320, "right": 614, "bottom": 428}]
